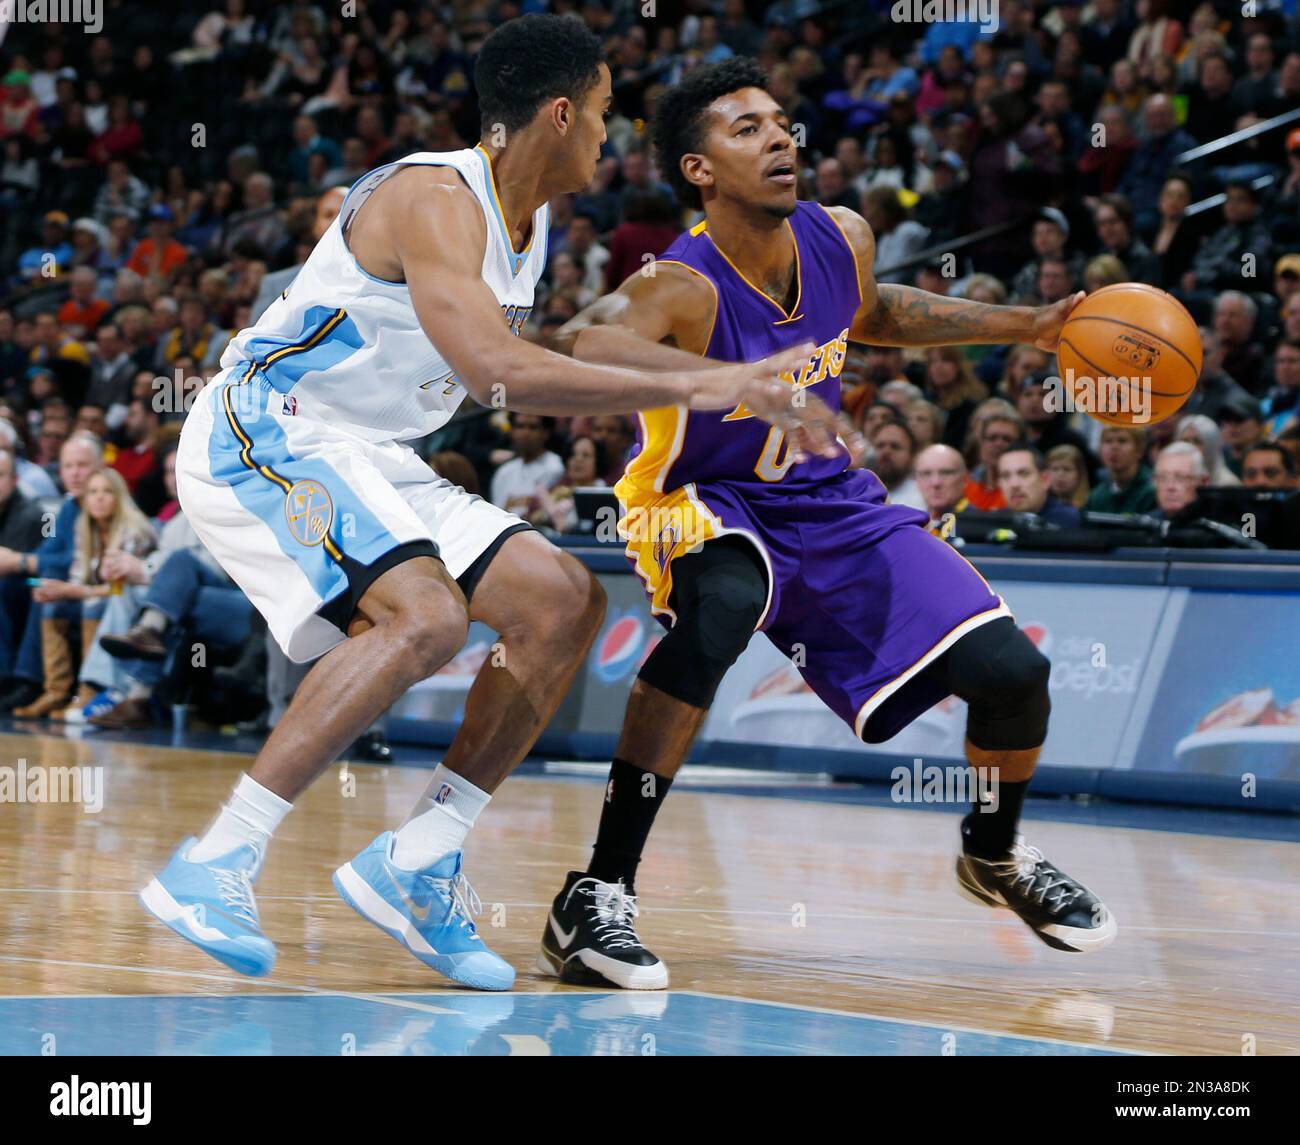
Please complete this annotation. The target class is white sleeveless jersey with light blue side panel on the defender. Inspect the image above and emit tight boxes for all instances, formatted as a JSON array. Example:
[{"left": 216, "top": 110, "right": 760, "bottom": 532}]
[{"left": 221, "top": 147, "right": 549, "bottom": 442}]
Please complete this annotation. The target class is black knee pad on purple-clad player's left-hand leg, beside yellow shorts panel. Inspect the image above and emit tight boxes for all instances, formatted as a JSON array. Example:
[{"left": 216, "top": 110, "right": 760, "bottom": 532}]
[{"left": 638, "top": 539, "right": 767, "bottom": 708}]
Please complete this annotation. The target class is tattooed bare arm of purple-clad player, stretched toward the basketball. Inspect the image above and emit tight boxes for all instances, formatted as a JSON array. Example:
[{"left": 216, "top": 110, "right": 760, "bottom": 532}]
[{"left": 828, "top": 207, "right": 1083, "bottom": 354}]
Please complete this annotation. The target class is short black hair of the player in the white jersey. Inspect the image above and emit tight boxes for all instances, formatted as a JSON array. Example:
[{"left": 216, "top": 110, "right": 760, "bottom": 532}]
[{"left": 475, "top": 13, "right": 605, "bottom": 134}]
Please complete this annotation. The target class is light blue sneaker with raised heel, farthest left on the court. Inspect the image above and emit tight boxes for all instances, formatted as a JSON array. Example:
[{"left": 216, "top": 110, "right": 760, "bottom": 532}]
[{"left": 140, "top": 838, "right": 276, "bottom": 977}]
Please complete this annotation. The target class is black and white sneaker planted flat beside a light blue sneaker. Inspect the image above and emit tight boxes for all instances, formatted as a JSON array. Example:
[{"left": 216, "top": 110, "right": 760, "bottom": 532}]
[{"left": 537, "top": 871, "right": 668, "bottom": 990}]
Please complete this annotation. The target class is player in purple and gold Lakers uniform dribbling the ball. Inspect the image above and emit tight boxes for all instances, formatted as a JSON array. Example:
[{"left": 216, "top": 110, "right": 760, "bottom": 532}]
[{"left": 538, "top": 60, "right": 1115, "bottom": 989}]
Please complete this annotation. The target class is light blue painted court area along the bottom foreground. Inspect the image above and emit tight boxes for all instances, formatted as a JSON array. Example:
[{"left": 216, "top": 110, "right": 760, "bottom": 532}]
[{"left": 0, "top": 990, "right": 1132, "bottom": 1057}]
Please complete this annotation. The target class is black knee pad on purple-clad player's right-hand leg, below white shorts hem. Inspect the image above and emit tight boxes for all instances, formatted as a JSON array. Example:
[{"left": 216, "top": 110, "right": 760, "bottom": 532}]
[{"left": 945, "top": 616, "right": 1052, "bottom": 751}]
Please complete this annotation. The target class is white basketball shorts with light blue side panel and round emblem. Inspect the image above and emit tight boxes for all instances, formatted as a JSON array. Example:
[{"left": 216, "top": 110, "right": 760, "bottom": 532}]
[{"left": 176, "top": 368, "right": 523, "bottom": 663}]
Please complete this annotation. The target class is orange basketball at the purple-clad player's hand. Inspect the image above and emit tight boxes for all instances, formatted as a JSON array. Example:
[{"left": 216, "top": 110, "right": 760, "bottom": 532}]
[{"left": 1057, "top": 282, "right": 1201, "bottom": 426}]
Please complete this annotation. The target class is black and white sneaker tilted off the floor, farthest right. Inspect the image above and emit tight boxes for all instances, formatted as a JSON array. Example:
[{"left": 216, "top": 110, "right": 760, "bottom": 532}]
[{"left": 957, "top": 836, "right": 1118, "bottom": 954}]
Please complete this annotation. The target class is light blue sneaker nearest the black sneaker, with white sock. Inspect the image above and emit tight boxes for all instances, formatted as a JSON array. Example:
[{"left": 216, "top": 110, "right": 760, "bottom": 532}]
[{"left": 334, "top": 830, "right": 515, "bottom": 990}]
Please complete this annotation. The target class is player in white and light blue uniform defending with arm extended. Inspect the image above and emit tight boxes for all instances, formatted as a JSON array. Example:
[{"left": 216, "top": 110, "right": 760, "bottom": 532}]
[{"left": 140, "top": 16, "right": 835, "bottom": 989}]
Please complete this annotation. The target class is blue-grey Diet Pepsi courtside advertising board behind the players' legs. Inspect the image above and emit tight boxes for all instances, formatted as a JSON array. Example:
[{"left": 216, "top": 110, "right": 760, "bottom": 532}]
[{"left": 394, "top": 573, "right": 1300, "bottom": 800}]
